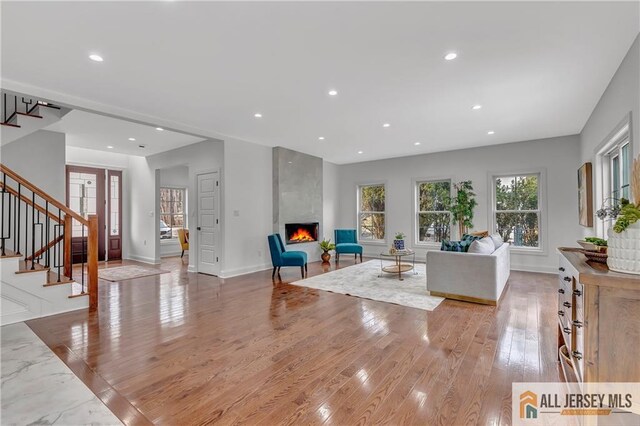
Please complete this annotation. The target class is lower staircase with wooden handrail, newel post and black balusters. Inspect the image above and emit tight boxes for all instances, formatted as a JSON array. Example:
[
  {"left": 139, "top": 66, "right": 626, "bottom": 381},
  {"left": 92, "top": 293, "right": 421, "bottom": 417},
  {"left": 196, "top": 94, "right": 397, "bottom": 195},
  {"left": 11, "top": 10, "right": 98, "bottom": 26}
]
[{"left": 0, "top": 164, "right": 98, "bottom": 325}]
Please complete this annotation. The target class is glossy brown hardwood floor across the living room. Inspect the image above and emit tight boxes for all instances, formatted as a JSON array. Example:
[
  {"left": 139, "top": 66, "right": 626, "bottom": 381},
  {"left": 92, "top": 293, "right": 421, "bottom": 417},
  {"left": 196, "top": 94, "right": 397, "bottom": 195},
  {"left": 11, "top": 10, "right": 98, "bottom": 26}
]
[{"left": 28, "top": 258, "right": 559, "bottom": 425}]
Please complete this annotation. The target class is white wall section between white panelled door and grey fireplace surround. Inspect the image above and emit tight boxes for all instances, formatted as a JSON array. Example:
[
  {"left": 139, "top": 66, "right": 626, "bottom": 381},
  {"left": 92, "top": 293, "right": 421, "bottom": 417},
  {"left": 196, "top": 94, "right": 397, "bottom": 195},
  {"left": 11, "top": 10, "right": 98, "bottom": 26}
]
[{"left": 221, "top": 139, "right": 273, "bottom": 277}]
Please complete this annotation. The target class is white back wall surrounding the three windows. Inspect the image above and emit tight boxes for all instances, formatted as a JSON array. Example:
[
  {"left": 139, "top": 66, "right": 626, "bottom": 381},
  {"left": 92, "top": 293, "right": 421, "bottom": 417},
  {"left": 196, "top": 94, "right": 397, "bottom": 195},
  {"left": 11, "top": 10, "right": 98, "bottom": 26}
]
[{"left": 336, "top": 135, "right": 581, "bottom": 272}]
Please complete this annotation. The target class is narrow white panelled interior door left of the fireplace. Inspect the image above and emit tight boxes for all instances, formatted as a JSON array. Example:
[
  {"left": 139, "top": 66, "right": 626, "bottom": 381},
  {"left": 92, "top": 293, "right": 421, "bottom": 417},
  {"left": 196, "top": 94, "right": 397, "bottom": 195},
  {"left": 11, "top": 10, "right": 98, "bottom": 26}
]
[{"left": 198, "top": 172, "right": 220, "bottom": 275}]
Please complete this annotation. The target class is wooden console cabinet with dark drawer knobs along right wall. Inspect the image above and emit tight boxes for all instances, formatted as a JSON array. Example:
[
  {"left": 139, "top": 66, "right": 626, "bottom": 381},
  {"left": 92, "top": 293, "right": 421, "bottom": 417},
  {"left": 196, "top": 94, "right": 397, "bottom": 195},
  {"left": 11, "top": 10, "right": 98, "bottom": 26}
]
[{"left": 558, "top": 248, "right": 640, "bottom": 382}]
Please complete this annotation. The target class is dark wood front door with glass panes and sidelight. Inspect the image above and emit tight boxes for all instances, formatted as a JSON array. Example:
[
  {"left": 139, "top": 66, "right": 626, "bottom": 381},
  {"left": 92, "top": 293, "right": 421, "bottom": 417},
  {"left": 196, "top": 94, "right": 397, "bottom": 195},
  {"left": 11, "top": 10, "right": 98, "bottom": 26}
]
[{"left": 66, "top": 166, "right": 122, "bottom": 263}]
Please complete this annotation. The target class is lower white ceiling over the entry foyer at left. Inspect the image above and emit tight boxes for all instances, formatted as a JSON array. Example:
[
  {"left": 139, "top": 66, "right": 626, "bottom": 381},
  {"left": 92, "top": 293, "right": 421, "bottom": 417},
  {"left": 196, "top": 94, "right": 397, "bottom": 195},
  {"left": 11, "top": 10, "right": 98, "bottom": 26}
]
[{"left": 46, "top": 110, "right": 203, "bottom": 156}]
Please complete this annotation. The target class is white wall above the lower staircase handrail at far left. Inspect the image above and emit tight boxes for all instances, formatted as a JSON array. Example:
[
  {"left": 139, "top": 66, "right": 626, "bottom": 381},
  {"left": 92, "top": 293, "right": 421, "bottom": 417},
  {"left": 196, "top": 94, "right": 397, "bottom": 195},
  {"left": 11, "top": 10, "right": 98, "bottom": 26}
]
[{"left": 0, "top": 130, "right": 66, "bottom": 203}]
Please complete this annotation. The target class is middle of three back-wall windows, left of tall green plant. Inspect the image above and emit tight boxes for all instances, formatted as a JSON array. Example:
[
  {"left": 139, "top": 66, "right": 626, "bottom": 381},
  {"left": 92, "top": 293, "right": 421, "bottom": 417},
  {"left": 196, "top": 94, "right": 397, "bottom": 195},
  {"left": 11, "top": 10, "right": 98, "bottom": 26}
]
[{"left": 416, "top": 180, "right": 451, "bottom": 244}]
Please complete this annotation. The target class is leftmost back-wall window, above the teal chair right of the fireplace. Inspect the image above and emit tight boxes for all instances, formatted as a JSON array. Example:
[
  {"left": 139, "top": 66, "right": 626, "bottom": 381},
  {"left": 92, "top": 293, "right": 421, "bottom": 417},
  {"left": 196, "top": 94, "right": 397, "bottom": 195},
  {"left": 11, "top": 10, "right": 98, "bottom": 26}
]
[{"left": 358, "top": 185, "right": 385, "bottom": 241}]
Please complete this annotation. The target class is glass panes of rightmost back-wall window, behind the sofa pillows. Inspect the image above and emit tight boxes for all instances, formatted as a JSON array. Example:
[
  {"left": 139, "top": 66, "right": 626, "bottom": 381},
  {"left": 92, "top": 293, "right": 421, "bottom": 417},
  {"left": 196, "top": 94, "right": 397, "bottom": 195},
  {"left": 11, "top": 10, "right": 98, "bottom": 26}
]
[{"left": 493, "top": 173, "right": 541, "bottom": 249}]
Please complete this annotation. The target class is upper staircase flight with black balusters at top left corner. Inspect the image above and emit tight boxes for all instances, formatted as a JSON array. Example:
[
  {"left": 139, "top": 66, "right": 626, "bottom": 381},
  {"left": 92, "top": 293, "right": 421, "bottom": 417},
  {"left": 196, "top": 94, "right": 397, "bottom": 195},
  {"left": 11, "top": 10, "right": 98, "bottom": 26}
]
[{"left": 0, "top": 92, "right": 71, "bottom": 145}]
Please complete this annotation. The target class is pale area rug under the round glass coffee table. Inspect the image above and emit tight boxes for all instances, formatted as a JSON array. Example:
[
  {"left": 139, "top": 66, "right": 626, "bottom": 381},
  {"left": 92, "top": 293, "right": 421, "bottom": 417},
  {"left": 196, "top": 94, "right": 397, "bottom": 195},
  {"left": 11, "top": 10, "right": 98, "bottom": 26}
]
[{"left": 291, "top": 260, "right": 444, "bottom": 311}]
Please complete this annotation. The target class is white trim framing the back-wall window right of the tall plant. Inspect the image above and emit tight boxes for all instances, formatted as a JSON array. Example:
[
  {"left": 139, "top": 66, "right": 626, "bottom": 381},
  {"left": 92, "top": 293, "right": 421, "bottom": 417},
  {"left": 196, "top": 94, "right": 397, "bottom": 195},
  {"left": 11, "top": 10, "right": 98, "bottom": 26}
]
[{"left": 488, "top": 168, "right": 549, "bottom": 256}]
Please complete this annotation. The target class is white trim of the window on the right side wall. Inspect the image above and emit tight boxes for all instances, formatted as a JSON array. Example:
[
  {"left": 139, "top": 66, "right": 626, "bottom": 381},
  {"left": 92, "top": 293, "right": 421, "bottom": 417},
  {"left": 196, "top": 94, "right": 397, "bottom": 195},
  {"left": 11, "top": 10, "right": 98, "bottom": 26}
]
[{"left": 593, "top": 113, "right": 638, "bottom": 239}]
